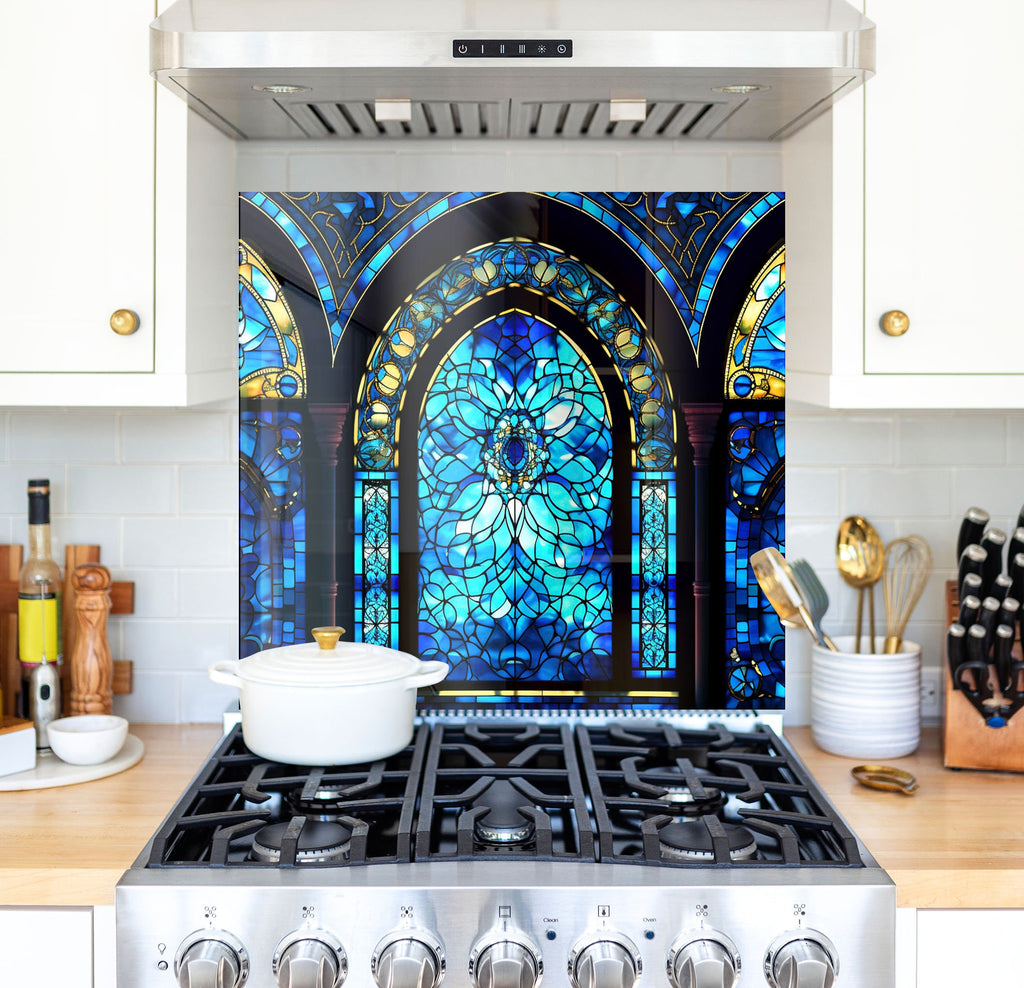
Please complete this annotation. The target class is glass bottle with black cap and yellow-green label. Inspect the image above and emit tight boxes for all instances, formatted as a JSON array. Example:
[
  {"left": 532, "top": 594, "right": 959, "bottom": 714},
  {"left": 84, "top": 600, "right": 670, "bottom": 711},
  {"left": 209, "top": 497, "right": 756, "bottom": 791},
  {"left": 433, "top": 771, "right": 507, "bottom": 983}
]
[{"left": 17, "top": 480, "right": 62, "bottom": 718}]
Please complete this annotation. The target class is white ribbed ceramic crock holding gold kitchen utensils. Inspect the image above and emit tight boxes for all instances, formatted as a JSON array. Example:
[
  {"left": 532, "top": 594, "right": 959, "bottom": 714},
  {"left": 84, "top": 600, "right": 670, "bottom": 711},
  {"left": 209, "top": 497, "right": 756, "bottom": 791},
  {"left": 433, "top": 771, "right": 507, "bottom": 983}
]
[{"left": 811, "top": 635, "right": 921, "bottom": 759}]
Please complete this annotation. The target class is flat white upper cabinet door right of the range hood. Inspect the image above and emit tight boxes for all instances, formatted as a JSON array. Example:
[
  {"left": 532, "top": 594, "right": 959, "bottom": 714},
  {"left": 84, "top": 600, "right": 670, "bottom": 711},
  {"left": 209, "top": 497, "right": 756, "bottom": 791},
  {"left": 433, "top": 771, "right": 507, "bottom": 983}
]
[{"left": 864, "top": 0, "right": 1024, "bottom": 374}]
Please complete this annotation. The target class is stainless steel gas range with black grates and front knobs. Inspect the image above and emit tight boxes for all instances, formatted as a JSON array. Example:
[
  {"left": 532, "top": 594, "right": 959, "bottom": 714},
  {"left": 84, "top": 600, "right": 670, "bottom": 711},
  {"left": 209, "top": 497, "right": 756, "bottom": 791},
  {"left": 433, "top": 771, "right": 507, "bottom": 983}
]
[{"left": 117, "top": 714, "right": 895, "bottom": 988}]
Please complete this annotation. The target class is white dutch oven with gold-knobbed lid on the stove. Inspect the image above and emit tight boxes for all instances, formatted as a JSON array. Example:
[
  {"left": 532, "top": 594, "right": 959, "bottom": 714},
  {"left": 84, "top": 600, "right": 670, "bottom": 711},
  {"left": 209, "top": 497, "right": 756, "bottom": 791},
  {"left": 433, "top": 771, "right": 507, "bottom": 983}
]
[{"left": 209, "top": 628, "right": 449, "bottom": 765}]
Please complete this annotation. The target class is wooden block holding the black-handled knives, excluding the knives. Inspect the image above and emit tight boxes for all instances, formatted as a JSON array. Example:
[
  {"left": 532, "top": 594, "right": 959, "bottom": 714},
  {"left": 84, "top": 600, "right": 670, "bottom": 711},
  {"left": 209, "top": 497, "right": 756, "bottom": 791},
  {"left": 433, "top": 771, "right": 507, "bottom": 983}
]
[{"left": 942, "top": 579, "right": 1024, "bottom": 772}]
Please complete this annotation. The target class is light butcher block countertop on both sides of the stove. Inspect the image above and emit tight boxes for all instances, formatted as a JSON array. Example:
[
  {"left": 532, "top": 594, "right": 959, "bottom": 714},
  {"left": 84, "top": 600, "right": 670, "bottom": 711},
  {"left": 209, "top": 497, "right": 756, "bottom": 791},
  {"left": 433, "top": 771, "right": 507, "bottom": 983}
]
[{"left": 0, "top": 725, "right": 1024, "bottom": 908}]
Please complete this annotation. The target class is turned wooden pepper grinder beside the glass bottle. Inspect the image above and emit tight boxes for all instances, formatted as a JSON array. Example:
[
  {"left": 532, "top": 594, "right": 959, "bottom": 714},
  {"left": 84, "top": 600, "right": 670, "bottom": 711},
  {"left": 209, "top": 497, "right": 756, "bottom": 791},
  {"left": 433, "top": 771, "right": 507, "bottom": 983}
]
[{"left": 69, "top": 563, "right": 114, "bottom": 717}]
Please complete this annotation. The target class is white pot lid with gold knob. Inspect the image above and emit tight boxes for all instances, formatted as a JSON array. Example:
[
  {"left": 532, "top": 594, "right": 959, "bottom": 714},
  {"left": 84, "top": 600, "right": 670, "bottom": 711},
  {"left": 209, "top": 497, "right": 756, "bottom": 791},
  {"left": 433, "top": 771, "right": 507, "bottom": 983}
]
[{"left": 237, "top": 628, "right": 424, "bottom": 688}]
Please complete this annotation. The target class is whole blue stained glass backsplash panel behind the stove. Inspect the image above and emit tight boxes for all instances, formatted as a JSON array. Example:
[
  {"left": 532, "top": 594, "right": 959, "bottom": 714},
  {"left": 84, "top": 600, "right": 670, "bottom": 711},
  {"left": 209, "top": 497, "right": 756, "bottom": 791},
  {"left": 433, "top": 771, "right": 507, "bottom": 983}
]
[{"left": 239, "top": 191, "right": 785, "bottom": 710}]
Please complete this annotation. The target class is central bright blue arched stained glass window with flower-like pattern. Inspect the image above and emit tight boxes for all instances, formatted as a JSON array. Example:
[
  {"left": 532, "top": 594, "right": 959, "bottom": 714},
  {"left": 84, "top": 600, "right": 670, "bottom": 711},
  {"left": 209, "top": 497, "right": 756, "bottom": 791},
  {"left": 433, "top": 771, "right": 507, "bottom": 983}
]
[{"left": 418, "top": 310, "right": 611, "bottom": 683}]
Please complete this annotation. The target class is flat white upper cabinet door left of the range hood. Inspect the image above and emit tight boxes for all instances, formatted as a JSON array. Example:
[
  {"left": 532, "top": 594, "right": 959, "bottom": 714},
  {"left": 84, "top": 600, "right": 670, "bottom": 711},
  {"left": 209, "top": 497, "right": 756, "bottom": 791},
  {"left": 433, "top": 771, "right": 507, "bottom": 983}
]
[{"left": 0, "top": 0, "right": 155, "bottom": 370}]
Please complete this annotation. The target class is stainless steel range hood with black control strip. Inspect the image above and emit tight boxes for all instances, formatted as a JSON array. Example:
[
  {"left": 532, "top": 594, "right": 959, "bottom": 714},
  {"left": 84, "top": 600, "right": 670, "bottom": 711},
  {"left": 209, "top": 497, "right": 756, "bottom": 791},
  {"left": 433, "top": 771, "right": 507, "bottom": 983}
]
[{"left": 151, "top": 0, "right": 874, "bottom": 140}]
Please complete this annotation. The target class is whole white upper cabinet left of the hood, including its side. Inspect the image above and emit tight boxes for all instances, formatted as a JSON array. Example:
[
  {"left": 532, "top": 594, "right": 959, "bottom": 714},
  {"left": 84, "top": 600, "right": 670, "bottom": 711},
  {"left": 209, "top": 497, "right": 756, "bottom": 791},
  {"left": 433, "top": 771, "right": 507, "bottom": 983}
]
[{"left": 0, "top": 0, "right": 237, "bottom": 405}]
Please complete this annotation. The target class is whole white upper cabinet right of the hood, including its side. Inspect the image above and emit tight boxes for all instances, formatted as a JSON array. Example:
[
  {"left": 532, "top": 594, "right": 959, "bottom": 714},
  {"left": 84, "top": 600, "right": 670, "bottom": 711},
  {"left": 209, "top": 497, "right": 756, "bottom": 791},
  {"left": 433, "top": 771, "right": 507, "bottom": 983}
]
[{"left": 783, "top": 0, "right": 1024, "bottom": 407}]
